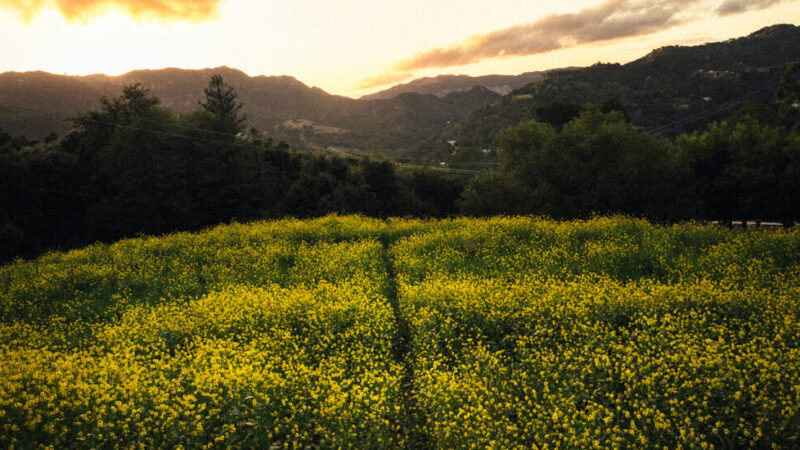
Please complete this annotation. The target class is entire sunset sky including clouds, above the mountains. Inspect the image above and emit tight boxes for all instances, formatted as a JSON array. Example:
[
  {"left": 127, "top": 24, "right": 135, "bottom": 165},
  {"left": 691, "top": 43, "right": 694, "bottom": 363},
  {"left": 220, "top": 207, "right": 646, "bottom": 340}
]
[{"left": 0, "top": 0, "right": 800, "bottom": 97}]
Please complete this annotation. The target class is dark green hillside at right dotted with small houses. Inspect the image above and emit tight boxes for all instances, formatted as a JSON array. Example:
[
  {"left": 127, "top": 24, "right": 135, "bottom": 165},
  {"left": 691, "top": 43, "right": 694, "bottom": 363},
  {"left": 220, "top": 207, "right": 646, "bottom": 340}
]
[{"left": 434, "top": 25, "right": 800, "bottom": 149}]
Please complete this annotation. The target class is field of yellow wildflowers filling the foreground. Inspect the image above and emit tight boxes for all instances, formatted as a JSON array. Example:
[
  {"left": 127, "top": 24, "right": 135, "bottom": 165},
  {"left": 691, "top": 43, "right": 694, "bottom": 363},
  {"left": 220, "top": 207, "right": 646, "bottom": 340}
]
[{"left": 0, "top": 216, "right": 800, "bottom": 448}]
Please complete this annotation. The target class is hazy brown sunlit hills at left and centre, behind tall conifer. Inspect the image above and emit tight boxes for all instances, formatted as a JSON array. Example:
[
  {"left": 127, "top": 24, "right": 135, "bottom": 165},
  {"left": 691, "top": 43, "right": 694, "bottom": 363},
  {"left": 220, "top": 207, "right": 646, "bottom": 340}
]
[{"left": 0, "top": 67, "right": 501, "bottom": 152}]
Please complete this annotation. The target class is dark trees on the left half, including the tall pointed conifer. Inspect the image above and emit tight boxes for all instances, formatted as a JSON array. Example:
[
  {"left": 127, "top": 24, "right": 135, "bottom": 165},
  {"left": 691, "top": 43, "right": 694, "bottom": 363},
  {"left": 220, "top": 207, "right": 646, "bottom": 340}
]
[{"left": 0, "top": 76, "right": 465, "bottom": 261}]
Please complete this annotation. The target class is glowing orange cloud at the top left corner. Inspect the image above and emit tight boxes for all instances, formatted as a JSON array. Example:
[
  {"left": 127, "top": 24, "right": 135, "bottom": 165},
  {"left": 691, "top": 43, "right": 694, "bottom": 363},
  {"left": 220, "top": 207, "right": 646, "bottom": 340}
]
[{"left": 0, "top": 0, "right": 224, "bottom": 22}]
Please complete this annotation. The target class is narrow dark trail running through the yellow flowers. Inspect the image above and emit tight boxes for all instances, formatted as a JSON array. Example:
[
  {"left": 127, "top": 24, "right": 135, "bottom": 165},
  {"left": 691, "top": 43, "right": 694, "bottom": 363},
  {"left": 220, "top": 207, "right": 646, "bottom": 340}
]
[{"left": 381, "top": 236, "right": 431, "bottom": 449}]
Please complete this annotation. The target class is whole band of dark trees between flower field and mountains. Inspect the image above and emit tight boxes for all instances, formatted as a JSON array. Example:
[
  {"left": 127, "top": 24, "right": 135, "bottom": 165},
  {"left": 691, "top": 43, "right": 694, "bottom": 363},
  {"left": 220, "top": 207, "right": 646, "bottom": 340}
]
[{"left": 0, "top": 64, "right": 800, "bottom": 261}]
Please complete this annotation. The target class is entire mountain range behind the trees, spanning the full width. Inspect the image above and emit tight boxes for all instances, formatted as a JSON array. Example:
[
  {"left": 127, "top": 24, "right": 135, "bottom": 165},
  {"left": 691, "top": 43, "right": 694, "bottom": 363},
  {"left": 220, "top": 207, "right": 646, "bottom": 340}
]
[{"left": 0, "top": 25, "right": 800, "bottom": 157}]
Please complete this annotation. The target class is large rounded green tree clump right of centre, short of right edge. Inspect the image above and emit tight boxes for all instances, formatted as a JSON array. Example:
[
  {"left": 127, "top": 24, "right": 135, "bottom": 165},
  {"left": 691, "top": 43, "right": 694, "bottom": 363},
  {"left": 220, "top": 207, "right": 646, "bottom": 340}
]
[{"left": 462, "top": 108, "right": 692, "bottom": 220}]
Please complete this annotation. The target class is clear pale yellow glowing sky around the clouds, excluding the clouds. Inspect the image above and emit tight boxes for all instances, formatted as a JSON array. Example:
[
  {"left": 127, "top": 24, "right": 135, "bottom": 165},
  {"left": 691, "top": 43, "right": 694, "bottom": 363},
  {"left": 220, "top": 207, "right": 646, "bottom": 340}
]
[{"left": 0, "top": 0, "right": 800, "bottom": 96}]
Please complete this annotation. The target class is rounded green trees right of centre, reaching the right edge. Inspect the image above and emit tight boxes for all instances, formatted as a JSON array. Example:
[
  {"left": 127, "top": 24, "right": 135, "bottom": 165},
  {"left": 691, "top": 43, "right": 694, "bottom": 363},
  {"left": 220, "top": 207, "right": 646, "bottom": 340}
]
[{"left": 460, "top": 99, "right": 800, "bottom": 224}]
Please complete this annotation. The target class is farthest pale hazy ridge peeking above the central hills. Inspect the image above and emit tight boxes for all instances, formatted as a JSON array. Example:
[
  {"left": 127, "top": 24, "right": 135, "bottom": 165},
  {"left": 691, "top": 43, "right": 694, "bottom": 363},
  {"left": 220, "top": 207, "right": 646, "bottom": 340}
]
[{"left": 361, "top": 72, "right": 547, "bottom": 100}]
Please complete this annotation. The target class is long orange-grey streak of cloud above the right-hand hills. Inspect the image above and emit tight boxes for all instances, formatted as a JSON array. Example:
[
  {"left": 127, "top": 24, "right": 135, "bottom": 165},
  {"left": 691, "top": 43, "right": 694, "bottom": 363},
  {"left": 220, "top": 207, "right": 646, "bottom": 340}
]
[{"left": 395, "top": 0, "right": 696, "bottom": 71}]
